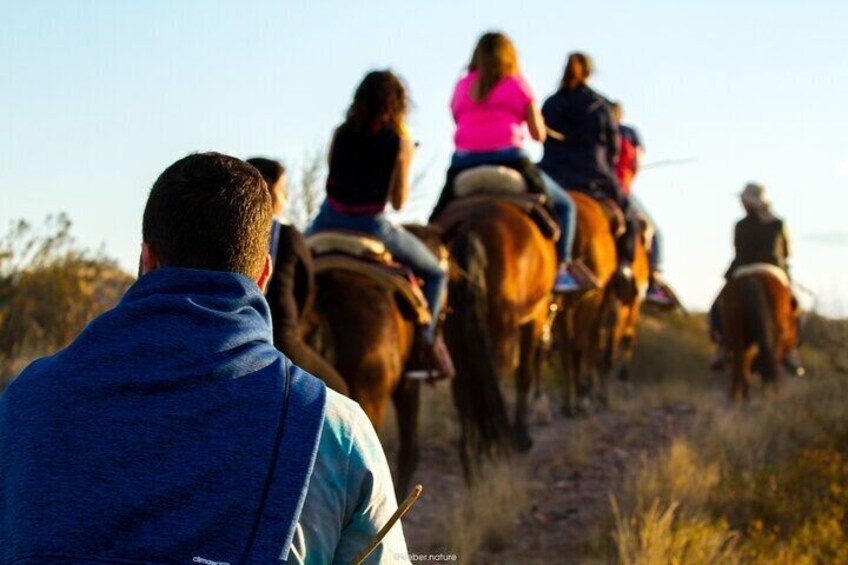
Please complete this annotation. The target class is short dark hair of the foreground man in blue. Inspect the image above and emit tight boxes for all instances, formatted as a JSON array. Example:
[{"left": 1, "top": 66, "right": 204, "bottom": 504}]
[{"left": 142, "top": 153, "right": 272, "bottom": 278}]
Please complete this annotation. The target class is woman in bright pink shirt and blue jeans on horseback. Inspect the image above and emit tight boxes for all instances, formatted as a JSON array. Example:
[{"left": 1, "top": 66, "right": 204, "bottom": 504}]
[{"left": 431, "top": 32, "right": 587, "bottom": 293}]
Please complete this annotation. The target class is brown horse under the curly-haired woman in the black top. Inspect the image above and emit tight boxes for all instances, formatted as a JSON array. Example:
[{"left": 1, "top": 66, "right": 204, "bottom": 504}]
[{"left": 306, "top": 226, "right": 440, "bottom": 496}]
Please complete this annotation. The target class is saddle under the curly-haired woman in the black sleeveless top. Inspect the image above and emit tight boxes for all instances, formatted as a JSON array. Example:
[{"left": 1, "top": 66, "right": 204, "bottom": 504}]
[{"left": 306, "top": 230, "right": 430, "bottom": 325}]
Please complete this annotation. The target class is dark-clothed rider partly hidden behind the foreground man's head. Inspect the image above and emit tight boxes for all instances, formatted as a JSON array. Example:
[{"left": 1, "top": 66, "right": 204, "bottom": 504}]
[{"left": 247, "top": 157, "right": 350, "bottom": 396}]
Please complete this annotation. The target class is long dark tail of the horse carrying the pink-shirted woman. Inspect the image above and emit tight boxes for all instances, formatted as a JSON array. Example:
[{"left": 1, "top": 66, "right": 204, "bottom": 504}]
[{"left": 445, "top": 231, "right": 511, "bottom": 478}]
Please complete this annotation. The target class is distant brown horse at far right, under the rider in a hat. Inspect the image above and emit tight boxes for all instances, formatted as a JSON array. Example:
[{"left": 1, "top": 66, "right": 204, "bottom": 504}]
[{"left": 719, "top": 268, "right": 797, "bottom": 402}]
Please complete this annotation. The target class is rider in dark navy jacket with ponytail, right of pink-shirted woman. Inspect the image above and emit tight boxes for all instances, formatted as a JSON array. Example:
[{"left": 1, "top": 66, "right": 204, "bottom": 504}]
[{"left": 539, "top": 52, "right": 638, "bottom": 279}]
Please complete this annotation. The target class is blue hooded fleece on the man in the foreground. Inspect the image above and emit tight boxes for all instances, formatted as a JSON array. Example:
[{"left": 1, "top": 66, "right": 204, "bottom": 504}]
[{"left": 0, "top": 268, "right": 326, "bottom": 565}]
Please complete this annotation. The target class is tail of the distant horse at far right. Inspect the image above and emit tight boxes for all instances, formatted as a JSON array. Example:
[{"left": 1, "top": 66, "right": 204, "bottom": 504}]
[{"left": 739, "top": 276, "right": 778, "bottom": 382}]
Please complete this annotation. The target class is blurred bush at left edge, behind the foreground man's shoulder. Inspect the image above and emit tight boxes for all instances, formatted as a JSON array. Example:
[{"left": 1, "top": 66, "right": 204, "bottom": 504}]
[{"left": 0, "top": 214, "right": 133, "bottom": 386}]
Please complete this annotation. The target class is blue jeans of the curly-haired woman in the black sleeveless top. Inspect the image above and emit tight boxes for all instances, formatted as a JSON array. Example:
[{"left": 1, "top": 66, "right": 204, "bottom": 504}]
[{"left": 306, "top": 202, "right": 448, "bottom": 341}]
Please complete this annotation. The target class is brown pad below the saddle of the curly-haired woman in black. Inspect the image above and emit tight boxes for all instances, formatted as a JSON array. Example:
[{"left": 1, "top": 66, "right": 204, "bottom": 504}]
[{"left": 315, "top": 254, "right": 431, "bottom": 325}]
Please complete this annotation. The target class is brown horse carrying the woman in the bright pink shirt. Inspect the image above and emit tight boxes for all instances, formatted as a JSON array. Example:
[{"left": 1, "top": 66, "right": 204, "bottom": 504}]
[{"left": 436, "top": 199, "right": 556, "bottom": 480}]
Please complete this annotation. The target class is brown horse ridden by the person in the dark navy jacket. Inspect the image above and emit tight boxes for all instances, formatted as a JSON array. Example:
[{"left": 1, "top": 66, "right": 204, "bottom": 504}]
[{"left": 557, "top": 191, "right": 618, "bottom": 416}]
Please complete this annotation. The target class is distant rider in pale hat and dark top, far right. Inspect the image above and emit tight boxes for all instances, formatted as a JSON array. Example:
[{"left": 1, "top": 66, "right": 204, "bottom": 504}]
[{"left": 709, "top": 182, "right": 805, "bottom": 376}]
